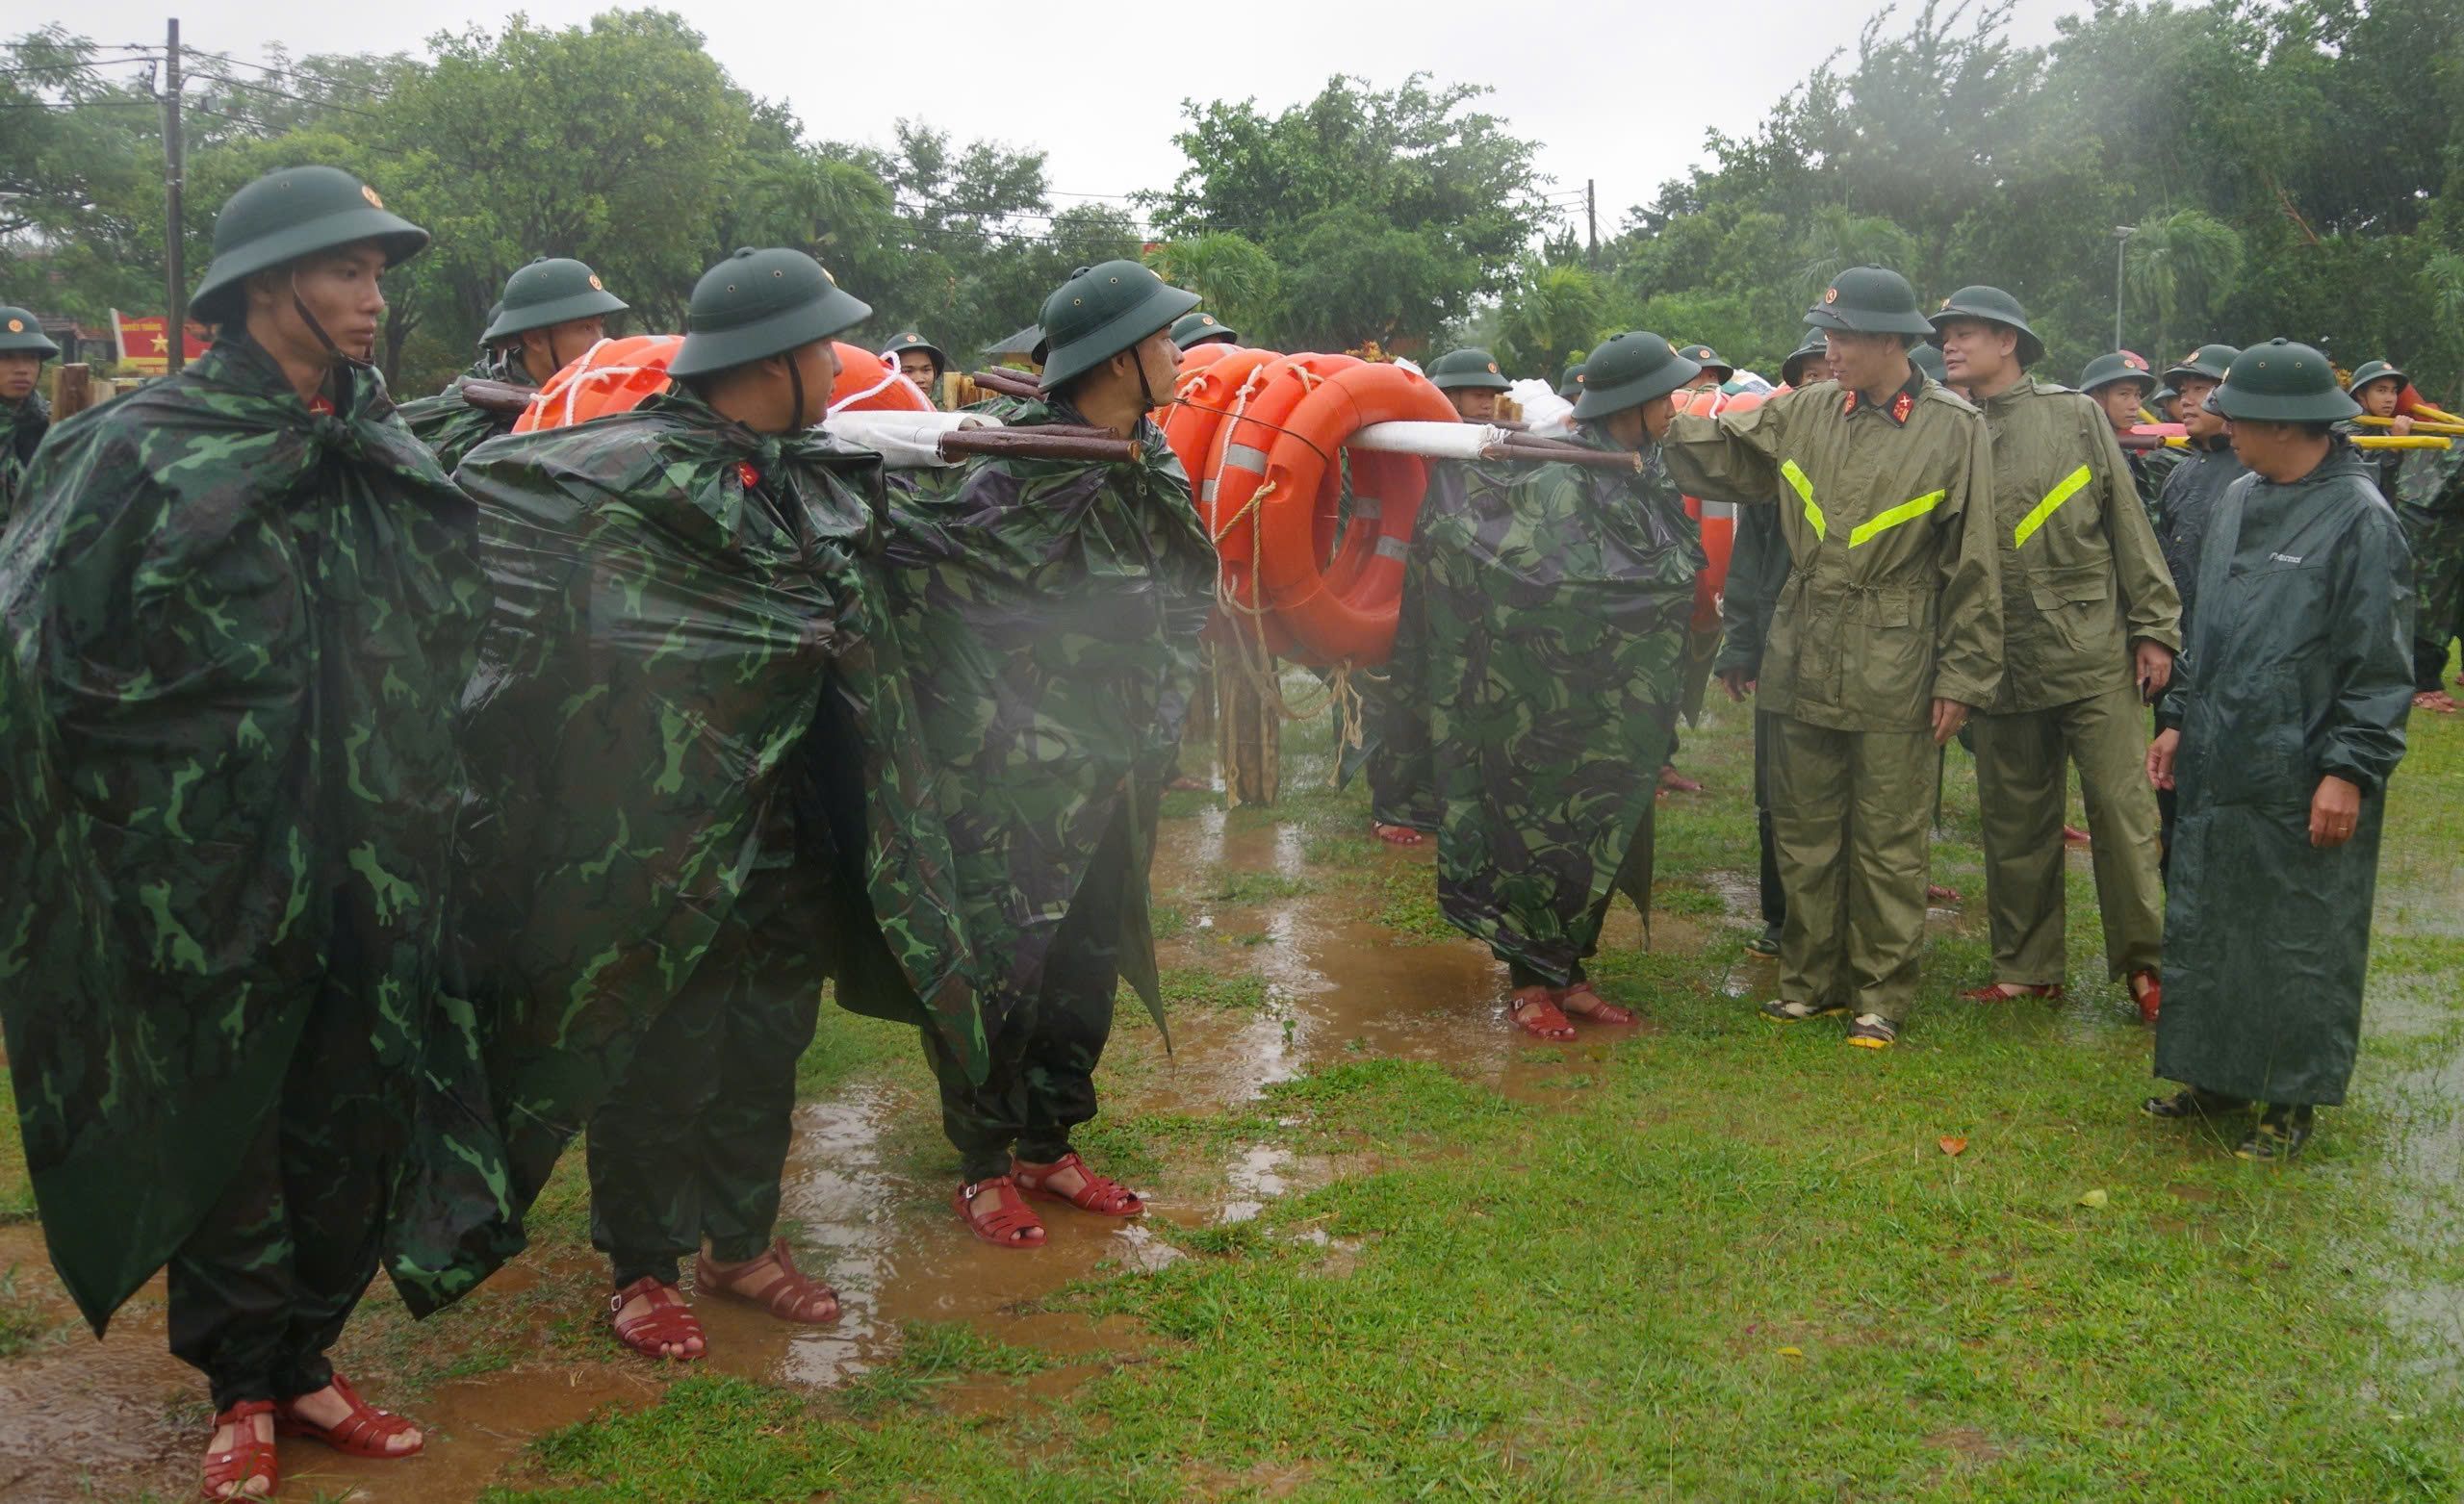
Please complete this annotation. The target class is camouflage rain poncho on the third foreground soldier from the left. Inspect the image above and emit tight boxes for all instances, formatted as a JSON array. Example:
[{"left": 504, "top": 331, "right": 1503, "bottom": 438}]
[{"left": 889, "top": 401, "right": 1215, "bottom": 1032}]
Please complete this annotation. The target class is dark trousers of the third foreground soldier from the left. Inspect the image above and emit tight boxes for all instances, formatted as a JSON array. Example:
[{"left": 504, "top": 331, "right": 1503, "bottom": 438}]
[{"left": 924, "top": 807, "right": 1145, "bottom": 1182}]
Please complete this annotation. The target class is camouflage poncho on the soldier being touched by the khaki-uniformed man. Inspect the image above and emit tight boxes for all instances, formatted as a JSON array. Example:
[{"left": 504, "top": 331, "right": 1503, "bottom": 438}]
[{"left": 1395, "top": 428, "right": 1703, "bottom": 984}]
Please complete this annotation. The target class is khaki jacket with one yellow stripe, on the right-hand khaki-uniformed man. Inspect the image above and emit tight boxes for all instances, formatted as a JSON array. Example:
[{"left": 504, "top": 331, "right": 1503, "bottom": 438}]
[{"left": 1984, "top": 376, "right": 2181, "bottom": 714}]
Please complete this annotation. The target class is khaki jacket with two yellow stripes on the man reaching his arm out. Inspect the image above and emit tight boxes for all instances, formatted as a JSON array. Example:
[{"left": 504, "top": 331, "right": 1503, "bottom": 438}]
[{"left": 1660, "top": 376, "right": 2003, "bottom": 731}]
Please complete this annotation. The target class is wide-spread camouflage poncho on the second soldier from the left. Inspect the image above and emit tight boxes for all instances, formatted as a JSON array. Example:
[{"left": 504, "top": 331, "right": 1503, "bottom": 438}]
[{"left": 395, "top": 392, "right": 986, "bottom": 1307}]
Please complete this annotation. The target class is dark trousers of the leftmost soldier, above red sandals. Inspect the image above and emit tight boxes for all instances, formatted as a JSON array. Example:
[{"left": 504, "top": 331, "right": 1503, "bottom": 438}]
[{"left": 167, "top": 955, "right": 412, "bottom": 1411}]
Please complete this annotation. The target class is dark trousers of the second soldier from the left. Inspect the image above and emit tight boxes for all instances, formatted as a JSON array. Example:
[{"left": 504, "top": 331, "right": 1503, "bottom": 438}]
[{"left": 589, "top": 864, "right": 828, "bottom": 1287}]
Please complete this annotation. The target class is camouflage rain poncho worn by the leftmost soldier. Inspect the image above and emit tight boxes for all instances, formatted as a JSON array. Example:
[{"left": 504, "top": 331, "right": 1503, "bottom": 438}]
[{"left": 0, "top": 337, "right": 485, "bottom": 1329}]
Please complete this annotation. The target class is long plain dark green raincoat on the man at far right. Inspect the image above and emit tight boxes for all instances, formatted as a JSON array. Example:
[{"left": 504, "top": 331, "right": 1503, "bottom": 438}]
[{"left": 2156, "top": 443, "right": 2412, "bottom": 1106}]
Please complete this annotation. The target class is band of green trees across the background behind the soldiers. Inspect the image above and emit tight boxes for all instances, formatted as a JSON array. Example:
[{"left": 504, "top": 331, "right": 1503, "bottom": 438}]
[{"left": 0, "top": 0, "right": 2464, "bottom": 394}]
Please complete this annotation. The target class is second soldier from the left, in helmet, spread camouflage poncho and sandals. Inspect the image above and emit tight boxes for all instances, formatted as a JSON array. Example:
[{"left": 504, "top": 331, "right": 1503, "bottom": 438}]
[{"left": 403, "top": 251, "right": 986, "bottom": 1359}]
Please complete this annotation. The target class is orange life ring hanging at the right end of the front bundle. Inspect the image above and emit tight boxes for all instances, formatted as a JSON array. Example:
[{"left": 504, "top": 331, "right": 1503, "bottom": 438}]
[{"left": 1254, "top": 362, "right": 1456, "bottom": 665}]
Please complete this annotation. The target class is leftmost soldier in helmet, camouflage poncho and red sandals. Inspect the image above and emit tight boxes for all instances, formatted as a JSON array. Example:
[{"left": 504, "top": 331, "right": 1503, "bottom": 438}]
[{"left": 0, "top": 167, "right": 463, "bottom": 1494}]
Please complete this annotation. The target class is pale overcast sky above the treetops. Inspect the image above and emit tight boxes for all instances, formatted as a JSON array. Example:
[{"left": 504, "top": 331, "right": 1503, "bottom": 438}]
[{"left": 38, "top": 0, "right": 2087, "bottom": 234}]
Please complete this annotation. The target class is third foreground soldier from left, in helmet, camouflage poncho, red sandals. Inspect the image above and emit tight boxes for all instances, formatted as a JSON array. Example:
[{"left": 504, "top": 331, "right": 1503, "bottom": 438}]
[{"left": 889, "top": 261, "right": 1215, "bottom": 1248}]
